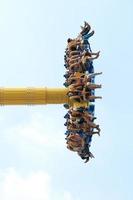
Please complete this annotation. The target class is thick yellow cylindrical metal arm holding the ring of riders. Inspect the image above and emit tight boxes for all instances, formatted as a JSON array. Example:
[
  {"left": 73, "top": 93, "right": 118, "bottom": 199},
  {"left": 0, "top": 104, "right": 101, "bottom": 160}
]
[{"left": 0, "top": 87, "right": 69, "bottom": 105}]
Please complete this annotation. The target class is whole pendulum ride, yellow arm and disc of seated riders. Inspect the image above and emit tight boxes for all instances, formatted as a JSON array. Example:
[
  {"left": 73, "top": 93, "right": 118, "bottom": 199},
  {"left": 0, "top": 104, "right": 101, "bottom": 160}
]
[{"left": 0, "top": 22, "right": 102, "bottom": 162}]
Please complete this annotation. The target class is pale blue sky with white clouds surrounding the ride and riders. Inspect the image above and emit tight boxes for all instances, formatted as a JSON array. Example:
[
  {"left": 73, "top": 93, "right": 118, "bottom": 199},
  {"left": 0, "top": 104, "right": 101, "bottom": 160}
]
[{"left": 0, "top": 0, "right": 133, "bottom": 200}]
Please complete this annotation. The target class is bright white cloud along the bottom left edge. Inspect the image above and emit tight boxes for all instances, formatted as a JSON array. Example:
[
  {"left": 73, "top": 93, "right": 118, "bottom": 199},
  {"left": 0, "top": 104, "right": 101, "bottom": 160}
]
[{"left": 0, "top": 168, "right": 73, "bottom": 200}]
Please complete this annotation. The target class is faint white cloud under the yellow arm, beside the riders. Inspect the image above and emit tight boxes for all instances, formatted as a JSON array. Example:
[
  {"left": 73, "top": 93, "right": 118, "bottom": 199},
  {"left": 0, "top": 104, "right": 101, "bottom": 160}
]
[{"left": 7, "top": 114, "right": 64, "bottom": 147}]
